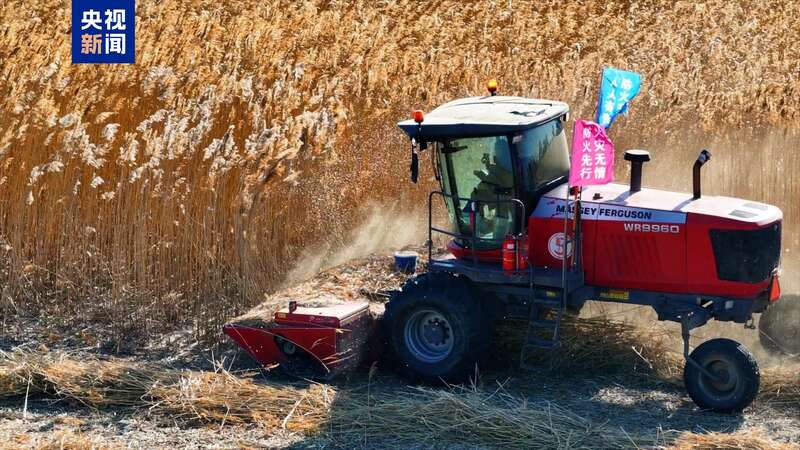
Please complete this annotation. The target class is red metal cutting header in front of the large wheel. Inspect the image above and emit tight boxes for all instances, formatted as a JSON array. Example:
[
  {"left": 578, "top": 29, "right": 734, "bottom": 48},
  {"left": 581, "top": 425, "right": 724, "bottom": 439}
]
[{"left": 223, "top": 302, "right": 372, "bottom": 375}]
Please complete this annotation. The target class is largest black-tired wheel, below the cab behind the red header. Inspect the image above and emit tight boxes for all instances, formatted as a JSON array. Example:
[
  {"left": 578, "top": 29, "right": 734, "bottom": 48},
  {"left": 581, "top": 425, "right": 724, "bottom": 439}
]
[{"left": 383, "top": 274, "right": 489, "bottom": 384}]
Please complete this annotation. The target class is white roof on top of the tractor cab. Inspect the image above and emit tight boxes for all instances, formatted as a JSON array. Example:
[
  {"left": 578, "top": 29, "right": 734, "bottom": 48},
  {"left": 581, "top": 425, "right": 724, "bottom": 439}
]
[{"left": 397, "top": 95, "right": 569, "bottom": 140}]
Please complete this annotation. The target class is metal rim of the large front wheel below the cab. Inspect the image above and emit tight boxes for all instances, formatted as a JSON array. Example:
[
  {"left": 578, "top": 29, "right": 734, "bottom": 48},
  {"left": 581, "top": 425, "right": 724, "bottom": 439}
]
[{"left": 403, "top": 309, "right": 454, "bottom": 363}]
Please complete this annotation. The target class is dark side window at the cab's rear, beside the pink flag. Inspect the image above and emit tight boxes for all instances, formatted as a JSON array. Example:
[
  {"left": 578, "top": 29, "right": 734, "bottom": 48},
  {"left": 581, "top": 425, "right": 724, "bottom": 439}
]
[{"left": 515, "top": 120, "right": 569, "bottom": 208}]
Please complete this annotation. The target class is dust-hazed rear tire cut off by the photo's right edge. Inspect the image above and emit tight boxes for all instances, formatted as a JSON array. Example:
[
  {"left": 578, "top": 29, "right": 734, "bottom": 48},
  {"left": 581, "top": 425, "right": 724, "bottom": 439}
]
[{"left": 758, "top": 295, "right": 800, "bottom": 356}]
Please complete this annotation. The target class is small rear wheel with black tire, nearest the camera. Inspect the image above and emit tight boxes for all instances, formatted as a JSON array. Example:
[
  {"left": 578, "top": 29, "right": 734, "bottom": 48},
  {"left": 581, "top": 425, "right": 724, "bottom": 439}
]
[{"left": 683, "top": 339, "right": 761, "bottom": 413}]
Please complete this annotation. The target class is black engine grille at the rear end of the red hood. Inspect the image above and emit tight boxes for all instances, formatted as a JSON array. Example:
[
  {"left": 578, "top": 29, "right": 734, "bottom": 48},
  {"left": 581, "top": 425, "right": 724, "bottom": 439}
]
[{"left": 711, "top": 222, "right": 781, "bottom": 283}]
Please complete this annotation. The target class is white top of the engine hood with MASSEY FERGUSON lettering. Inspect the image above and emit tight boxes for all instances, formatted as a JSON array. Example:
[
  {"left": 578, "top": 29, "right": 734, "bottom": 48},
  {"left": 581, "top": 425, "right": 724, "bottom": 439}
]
[{"left": 536, "top": 183, "right": 783, "bottom": 228}]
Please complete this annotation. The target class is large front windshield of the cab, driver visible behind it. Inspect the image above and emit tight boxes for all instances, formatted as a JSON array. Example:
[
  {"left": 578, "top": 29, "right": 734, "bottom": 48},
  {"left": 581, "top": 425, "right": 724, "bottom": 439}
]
[{"left": 438, "top": 136, "right": 514, "bottom": 248}]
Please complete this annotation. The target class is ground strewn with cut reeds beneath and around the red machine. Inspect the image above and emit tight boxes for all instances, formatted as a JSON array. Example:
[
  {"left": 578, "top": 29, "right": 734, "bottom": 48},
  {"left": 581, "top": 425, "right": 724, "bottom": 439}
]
[{"left": 0, "top": 251, "right": 800, "bottom": 449}]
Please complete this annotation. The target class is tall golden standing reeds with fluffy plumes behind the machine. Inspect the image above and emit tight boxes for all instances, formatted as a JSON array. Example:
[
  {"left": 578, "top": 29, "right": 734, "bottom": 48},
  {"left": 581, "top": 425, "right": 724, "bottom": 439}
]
[{"left": 0, "top": 0, "right": 800, "bottom": 337}]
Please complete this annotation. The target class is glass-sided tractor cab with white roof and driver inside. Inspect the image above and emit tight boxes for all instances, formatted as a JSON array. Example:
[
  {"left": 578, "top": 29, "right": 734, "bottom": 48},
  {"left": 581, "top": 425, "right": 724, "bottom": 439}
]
[{"left": 398, "top": 96, "right": 569, "bottom": 262}]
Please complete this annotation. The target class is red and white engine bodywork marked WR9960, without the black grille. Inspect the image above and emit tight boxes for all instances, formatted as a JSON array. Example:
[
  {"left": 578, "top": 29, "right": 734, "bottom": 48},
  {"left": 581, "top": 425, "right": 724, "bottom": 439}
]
[{"left": 450, "top": 183, "right": 783, "bottom": 298}]
